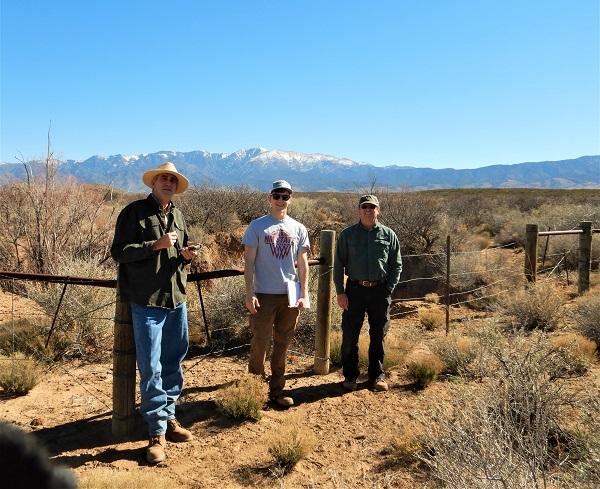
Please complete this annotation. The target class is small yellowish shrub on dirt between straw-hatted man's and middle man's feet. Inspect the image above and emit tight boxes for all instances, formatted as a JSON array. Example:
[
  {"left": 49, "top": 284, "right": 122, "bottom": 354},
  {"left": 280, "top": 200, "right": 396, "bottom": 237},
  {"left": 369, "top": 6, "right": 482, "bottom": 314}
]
[{"left": 216, "top": 374, "right": 268, "bottom": 421}]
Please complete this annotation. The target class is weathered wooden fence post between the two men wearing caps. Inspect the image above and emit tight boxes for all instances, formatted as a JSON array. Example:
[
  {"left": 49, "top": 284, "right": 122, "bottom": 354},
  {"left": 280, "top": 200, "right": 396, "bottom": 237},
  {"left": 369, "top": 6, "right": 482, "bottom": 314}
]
[{"left": 313, "top": 229, "right": 335, "bottom": 375}]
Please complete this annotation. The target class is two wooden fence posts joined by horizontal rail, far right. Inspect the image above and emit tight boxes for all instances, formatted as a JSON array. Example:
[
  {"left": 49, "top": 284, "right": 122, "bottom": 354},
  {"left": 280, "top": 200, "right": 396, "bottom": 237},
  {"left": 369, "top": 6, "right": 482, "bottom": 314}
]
[{"left": 525, "top": 221, "right": 600, "bottom": 294}]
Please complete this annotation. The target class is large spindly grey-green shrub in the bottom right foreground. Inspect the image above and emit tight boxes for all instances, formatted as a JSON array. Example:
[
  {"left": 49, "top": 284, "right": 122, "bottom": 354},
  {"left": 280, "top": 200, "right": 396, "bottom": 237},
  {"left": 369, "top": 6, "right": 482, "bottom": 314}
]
[{"left": 422, "top": 334, "right": 584, "bottom": 488}]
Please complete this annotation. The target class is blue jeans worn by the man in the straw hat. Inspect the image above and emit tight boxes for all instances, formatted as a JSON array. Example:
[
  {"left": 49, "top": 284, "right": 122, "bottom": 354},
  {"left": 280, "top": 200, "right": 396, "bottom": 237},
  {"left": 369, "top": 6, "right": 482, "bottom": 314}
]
[{"left": 131, "top": 302, "right": 188, "bottom": 436}]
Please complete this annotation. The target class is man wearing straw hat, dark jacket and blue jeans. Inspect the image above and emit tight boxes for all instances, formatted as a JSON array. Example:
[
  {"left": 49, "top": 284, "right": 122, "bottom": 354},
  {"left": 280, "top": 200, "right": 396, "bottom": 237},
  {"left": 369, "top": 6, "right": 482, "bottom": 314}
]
[{"left": 111, "top": 162, "right": 197, "bottom": 464}]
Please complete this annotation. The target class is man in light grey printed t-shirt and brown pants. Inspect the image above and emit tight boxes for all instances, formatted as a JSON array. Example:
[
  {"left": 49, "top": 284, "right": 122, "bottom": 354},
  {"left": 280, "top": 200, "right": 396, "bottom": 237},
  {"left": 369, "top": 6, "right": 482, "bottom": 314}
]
[{"left": 242, "top": 180, "right": 310, "bottom": 407}]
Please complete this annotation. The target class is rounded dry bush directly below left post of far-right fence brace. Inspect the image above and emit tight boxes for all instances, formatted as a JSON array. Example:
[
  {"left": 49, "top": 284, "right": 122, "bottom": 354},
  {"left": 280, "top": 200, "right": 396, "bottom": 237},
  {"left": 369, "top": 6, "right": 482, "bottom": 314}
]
[{"left": 498, "top": 281, "right": 564, "bottom": 331}]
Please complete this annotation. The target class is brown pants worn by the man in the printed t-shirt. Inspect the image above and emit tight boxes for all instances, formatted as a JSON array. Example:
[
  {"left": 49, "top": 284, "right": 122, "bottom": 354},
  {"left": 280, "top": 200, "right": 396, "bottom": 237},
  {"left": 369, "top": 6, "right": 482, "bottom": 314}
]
[{"left": 248, "top": 294, "right": 300, "bottom": 396}]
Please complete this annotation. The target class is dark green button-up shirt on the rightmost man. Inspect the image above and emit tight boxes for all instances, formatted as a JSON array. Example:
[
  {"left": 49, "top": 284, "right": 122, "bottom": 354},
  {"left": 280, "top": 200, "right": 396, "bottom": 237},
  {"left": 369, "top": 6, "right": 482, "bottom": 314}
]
[{"left": 333, "top": 222, "right": 402, "bottom": 294}]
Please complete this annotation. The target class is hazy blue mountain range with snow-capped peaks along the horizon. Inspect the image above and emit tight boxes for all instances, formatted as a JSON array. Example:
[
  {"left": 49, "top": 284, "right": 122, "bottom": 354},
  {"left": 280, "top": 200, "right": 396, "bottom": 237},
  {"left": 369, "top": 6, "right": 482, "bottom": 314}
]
[{"left": 0, "top": 148, "right": 600, "bottom": 191}]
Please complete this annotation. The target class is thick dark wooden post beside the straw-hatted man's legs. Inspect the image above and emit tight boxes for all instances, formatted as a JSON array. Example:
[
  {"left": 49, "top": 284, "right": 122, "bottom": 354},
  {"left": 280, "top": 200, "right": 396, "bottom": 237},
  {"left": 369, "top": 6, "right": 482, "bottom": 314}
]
[{"left": 112, "top": 284, "right": 135, "bottom": 436}]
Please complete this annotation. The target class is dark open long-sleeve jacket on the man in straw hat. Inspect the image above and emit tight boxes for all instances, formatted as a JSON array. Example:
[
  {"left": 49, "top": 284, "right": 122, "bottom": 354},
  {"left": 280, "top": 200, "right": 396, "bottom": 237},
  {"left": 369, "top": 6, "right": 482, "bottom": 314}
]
[{"left": 110, "top": 194, "right": 188, "bottom": 309}]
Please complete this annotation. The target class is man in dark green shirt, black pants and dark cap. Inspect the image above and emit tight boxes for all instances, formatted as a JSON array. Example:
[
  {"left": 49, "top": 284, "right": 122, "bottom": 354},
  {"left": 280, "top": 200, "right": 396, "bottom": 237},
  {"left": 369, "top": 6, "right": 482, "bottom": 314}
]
[{"left": 333, "top": 195, "right": 402, "bottom": 391}]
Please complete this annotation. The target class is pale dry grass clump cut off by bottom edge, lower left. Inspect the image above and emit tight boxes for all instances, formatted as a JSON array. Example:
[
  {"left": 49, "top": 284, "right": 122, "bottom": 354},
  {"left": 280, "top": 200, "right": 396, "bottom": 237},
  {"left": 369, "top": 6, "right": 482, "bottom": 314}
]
[{"left": 78, "top": 467, "right": 174, "bottom": 489}]
